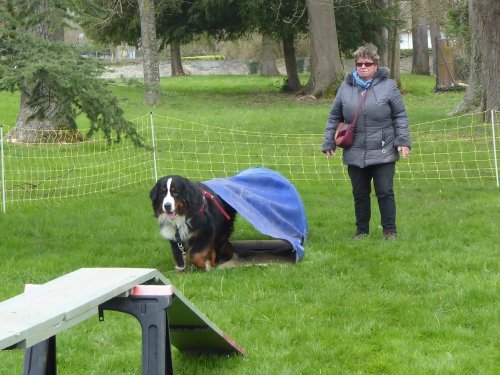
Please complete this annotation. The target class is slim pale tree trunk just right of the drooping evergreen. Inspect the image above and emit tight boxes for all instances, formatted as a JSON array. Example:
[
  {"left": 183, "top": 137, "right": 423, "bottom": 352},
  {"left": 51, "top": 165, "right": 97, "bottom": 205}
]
[{"left": 138, "top": 0, "right": 161, "bottom": 105}]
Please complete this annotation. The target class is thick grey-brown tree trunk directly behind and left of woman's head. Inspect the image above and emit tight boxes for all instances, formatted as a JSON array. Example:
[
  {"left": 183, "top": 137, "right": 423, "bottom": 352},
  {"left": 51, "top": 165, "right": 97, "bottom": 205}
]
[{"left": 305, "top": 0, "right": 344, "bottom": 97}]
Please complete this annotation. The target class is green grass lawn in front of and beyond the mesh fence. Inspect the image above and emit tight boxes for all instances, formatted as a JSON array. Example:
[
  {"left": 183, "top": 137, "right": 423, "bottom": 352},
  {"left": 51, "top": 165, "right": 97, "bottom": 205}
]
[{"left": 0, "top": 75, "right": 500, "bottom": 375}]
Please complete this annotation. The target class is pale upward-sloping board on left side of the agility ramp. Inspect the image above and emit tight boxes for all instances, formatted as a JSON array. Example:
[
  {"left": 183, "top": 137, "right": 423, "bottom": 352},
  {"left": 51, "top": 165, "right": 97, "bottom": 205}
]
[{"left": 0, "top": 268, "right": 168, "bottom": 349}]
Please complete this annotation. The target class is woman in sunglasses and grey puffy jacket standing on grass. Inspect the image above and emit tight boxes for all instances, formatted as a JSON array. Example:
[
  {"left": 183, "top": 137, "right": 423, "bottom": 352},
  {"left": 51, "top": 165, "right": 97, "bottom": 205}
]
[{"left": 322, "top": 44, "right": 411, "bottom": 240}]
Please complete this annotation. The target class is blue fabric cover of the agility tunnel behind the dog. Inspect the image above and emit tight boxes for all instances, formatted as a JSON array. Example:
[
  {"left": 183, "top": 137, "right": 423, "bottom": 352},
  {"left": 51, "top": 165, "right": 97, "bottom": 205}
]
[{"left": 203, "top": 168, "right": 307, "bottom": 262}]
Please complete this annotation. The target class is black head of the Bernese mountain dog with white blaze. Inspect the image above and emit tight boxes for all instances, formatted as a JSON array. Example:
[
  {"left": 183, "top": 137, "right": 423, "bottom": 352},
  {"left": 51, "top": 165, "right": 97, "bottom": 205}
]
[{"left": 149, "top": 175, "right": 202, "bottom": 219}]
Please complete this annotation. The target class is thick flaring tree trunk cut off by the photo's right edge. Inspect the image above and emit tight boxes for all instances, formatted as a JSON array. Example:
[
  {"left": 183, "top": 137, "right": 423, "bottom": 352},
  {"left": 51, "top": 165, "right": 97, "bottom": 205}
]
[{"left": 451, "top": 0, "right": 500, "bottom": 114}]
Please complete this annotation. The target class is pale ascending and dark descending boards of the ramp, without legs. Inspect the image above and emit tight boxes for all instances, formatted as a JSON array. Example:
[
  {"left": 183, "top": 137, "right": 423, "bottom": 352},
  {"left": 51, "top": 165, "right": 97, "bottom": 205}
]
[{"left": 0, "top": 268, "right": 245, "bottom": 354}]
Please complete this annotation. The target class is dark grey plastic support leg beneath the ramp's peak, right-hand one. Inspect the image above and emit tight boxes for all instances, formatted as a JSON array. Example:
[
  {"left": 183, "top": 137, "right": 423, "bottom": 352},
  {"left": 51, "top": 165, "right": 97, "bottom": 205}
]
[{"left": 99, "top": 295, "right": 174, "bottom": 375}]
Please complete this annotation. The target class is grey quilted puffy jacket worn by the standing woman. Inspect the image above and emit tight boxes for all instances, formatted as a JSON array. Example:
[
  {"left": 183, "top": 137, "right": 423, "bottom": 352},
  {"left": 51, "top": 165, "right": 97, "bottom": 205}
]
[{"left": 322, "top": 67, "right": 411, "bottom": 168}]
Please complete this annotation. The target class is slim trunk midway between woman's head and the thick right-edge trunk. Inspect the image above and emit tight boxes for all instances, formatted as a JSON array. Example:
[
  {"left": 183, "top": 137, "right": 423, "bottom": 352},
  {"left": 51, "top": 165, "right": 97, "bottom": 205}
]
[{"left": 411, "top": 0, "right": 430, "bottom": 75}]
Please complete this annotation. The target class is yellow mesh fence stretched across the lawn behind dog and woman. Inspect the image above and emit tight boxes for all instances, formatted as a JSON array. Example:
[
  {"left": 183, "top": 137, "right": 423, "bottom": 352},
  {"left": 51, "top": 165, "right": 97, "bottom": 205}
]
[{"left": 1, "top": 113, "right": 500, "bottom": 211}]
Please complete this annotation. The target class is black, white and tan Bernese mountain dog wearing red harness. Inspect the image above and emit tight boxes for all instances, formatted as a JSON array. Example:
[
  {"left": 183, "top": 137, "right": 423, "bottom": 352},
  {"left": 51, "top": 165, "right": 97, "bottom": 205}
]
[{"left": 149, "top": 175, "right": 236, "bottom": 271}]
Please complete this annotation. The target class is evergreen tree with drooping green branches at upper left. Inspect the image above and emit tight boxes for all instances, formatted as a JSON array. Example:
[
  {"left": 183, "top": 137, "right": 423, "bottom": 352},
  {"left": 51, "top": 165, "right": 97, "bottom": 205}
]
[{"left": 0, "top": 0, "right": 140, "bottom": 144}]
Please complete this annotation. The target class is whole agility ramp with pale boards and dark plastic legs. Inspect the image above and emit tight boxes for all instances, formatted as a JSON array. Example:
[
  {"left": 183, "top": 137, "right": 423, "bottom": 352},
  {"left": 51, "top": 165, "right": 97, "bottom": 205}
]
[{"left": 0, "top": 268, "right": 245, "bottom": 375}]
